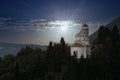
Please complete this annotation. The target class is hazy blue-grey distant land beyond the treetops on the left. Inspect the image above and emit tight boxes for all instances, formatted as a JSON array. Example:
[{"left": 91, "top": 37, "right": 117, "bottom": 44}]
[{"left": 0, "top": 42, "right": 47, "bottom": 57}]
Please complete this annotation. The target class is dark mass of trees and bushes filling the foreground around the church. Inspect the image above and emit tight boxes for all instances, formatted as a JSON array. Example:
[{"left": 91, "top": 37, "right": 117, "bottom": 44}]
[{"left": 0, "top": 26, "right": 120, "bottom": 80}]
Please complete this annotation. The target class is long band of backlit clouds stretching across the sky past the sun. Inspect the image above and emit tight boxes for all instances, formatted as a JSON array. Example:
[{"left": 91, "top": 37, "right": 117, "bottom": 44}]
[{"left": 0, "top": 18, "right": 98, "bottom": 32}]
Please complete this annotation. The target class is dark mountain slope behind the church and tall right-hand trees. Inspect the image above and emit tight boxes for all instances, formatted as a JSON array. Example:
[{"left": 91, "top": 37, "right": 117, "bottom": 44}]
[{"left": 90, "top": 17, "right": 120, "bottom": 42}]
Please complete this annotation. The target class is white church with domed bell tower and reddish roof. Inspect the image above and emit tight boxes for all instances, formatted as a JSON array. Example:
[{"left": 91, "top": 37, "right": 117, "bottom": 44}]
[{"left": 71, "top": 24, "right": 91, "bottom": 58}]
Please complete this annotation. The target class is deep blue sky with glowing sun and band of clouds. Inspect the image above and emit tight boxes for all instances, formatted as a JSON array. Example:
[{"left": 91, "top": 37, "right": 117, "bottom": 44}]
[{"left": 0, "top": 0, "right": 120, "bottom": 45}]
